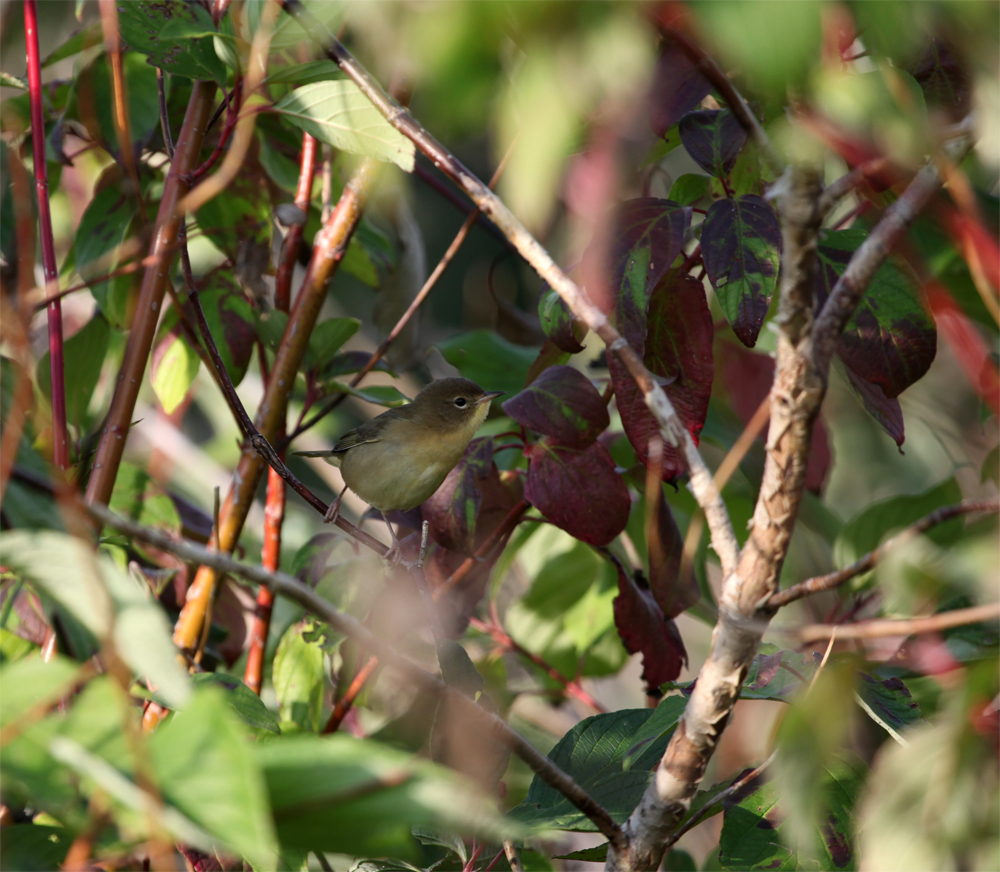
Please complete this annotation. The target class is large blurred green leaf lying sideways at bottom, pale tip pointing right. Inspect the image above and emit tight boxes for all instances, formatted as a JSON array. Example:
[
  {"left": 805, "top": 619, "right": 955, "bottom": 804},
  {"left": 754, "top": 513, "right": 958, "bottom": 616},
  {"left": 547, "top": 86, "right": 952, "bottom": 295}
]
[{"left": 256, "top": 733, "right": 519, "bottom": 860}]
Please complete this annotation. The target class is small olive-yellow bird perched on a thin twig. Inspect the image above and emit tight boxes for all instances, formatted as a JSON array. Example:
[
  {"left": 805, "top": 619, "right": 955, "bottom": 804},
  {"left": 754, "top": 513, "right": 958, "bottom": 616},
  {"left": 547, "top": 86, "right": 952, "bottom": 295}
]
[{"left": 294, "top": 378, "right": 503, "bottom": 554}]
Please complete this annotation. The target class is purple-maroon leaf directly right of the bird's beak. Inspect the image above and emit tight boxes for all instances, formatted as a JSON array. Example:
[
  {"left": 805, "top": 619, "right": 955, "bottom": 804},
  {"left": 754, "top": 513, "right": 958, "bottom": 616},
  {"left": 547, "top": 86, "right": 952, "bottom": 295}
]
[{"left": 503, "top": 366, "right": 611, "bottom": 448}]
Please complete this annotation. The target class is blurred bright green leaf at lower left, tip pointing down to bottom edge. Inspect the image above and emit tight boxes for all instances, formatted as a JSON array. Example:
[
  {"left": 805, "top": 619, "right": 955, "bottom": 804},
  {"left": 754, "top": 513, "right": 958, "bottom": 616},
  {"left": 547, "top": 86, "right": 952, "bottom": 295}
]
[{"left": 149, "top": 687, "right": 277, "bottom": 869}]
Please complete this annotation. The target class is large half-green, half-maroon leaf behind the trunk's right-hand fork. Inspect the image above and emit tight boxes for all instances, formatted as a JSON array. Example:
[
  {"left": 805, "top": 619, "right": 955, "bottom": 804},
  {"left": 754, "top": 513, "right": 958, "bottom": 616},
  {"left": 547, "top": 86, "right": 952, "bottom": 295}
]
[{"left": 816, "top": 228, "right": 937, "bottom": 399}]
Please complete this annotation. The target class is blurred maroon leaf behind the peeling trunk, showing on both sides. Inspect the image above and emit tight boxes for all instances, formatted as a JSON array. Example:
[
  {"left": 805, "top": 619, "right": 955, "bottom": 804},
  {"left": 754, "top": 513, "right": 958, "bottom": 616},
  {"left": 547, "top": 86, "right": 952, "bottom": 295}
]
[{"left": 718, "top": 342, "right": 832, "bottom": 493}]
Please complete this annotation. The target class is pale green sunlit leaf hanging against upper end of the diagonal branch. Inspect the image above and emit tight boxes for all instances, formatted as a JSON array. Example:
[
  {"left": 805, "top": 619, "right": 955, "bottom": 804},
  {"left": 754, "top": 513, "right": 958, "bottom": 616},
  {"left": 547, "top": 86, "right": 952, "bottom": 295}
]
[{"left": 274, "top": 80, "right": 414, "bottom": 173}]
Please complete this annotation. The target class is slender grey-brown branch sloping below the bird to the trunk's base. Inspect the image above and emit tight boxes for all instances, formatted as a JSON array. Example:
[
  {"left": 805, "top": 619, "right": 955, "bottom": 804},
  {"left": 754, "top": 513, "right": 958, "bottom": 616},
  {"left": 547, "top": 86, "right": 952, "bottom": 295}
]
[{"left": 86, "top": 504, "right": 622, "bottom": 845}]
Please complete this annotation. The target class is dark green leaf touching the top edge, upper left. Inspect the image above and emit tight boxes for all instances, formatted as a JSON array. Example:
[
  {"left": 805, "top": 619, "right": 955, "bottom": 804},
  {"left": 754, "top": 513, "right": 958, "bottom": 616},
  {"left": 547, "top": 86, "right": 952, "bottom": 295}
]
[{"left": 118, "top": 0, "right": 228, "bottom": 85}]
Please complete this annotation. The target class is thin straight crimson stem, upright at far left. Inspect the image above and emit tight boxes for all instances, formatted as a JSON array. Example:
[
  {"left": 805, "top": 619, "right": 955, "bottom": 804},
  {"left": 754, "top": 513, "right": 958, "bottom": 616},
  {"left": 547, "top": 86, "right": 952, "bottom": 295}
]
[{"left": 24, "top": 0, "right": 69, "bottom": 469}]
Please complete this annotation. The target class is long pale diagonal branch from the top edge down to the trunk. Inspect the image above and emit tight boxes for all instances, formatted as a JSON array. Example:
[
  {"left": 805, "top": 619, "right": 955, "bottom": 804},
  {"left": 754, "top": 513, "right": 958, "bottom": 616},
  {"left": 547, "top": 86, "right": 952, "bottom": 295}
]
[{"left": 281, "top": 0, "right": 739, "bottom": 575}]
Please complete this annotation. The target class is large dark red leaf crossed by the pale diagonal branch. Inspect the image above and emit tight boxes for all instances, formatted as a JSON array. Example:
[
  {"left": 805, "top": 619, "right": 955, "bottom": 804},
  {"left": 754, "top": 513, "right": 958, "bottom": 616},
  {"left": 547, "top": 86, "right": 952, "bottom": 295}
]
[{"left": 608, "top": 274, "right": 715, "bottom": 481}]
